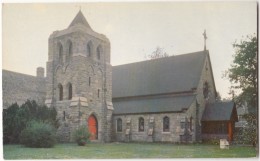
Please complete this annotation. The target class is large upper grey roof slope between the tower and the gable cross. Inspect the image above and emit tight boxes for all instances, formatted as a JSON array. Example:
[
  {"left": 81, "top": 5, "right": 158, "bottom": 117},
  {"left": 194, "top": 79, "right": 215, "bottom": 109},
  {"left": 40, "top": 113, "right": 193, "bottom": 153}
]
[{"left": 112, "top": 51, "right": 208, "bottom": 98}]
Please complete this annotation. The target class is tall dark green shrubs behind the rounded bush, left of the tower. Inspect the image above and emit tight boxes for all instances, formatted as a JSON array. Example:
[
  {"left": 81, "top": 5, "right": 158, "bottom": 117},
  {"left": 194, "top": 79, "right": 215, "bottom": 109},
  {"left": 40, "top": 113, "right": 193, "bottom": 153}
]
[{"left": 3, "top": 100, "right": 59, "bottom": 144}]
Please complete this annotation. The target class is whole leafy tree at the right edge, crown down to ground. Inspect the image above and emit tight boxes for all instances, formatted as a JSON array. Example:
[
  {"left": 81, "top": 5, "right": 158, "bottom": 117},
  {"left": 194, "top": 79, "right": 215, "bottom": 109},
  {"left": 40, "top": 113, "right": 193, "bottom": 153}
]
[{"left": 225, "top": 34, "right": 258, "bottom": 145}]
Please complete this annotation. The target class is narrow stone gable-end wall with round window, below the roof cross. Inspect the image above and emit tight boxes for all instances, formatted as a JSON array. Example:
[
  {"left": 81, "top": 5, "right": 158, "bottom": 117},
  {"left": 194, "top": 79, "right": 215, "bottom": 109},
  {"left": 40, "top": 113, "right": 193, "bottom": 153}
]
[{"left": 195, "top": 52, "right": 216, "bottom": 141}]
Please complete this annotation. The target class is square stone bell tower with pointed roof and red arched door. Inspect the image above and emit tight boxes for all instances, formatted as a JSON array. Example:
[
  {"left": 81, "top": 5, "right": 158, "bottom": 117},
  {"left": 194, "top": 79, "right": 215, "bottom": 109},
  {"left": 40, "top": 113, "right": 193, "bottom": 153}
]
[{"left": 45, "top": 11, "right": 113, "bottom": 142}]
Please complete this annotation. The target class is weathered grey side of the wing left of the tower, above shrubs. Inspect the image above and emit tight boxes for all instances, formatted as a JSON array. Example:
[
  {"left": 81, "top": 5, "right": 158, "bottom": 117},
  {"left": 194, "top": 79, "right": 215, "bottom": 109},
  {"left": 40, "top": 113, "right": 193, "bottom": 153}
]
[{"left": 2, "top": 70, "right": 46, "bottom": 109}]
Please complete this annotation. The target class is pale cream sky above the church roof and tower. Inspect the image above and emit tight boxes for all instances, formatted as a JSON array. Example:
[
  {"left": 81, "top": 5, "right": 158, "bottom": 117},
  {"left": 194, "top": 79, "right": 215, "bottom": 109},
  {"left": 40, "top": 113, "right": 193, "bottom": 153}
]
[{"left": 2, "top": 1, "right": 257, "bottom": 98}]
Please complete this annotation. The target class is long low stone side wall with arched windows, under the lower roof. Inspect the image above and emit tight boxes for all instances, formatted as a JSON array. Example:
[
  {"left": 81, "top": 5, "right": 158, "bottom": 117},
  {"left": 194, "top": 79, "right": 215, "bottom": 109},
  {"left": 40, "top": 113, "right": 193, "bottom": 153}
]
[{"left": 113, "top": 106, "right": 195, "bottom": 143}]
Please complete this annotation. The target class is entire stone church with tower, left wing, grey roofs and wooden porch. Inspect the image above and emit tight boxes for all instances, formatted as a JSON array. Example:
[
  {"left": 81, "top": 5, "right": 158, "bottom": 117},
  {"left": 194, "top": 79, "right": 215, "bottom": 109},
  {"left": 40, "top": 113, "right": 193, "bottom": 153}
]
[{"left": 2, "top": 11, "right": 237, "bottom": 143}]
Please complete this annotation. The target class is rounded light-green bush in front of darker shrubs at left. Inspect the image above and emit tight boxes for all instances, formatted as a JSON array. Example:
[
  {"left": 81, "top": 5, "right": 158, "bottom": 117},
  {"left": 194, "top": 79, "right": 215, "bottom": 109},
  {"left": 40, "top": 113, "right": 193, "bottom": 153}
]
[{"left": 20, "top": 120, "right": 56, "bottom": 148}]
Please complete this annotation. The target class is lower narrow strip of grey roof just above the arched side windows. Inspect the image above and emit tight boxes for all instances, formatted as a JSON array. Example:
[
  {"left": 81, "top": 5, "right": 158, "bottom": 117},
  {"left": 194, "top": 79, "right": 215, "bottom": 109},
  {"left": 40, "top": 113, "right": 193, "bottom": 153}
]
[{"left": 113, "top": 95, "right": 195, "bottom": 115}]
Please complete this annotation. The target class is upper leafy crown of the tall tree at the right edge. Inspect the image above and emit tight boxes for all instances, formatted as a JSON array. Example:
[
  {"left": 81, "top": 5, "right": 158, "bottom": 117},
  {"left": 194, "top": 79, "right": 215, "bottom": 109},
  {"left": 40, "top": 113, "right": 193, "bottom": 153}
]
[{"left": 225, "top": 35, "right": 257, "bottom": 112}]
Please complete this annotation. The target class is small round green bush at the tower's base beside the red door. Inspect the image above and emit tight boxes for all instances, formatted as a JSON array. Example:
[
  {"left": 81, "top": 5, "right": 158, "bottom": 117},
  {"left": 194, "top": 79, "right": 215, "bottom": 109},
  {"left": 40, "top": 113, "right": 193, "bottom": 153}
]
[{"left": 73, "top": 125, "right": 90, "bottom": 146}]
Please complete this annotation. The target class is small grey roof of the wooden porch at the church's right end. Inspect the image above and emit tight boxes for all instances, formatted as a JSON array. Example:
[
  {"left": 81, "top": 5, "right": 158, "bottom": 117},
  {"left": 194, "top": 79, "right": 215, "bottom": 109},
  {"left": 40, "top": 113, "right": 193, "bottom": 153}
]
[{"left": 202, "top": 102, "right": 237, "bottom": 121}]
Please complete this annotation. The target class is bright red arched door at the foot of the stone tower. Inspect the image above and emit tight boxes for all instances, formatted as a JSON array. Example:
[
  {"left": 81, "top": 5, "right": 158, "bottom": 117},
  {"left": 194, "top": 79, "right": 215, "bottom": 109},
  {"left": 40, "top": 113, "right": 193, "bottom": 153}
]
[{"left": 88, "top": 115, "right": 98, "bottom": 140}]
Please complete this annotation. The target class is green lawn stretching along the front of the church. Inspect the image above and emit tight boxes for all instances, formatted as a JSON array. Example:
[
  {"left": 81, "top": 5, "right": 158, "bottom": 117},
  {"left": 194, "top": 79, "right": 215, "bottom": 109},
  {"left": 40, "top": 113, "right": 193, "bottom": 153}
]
[{"left": 3, "top": 143, "right": 256, "bottom": 159}]
